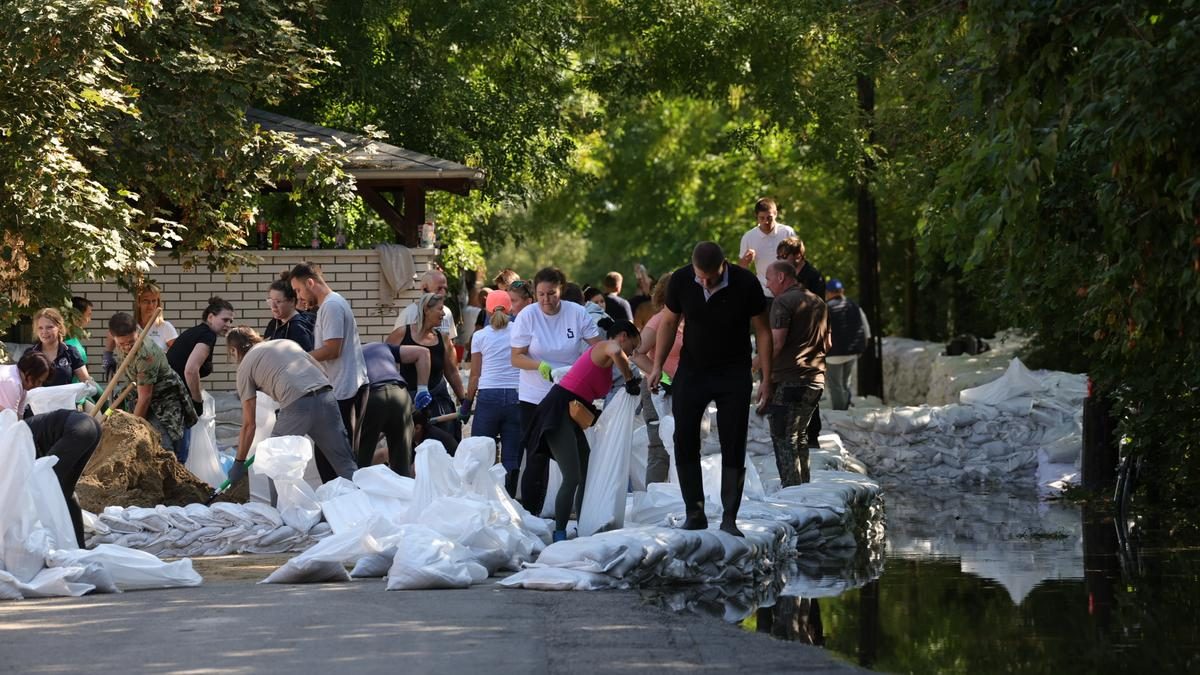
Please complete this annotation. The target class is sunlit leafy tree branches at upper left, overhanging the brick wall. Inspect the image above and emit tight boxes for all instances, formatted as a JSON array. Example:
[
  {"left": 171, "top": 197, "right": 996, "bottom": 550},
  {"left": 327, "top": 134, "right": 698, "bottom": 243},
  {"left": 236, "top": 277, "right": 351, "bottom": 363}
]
[{"left": 0, "top": 0, "right": 352, "bottom": 321}]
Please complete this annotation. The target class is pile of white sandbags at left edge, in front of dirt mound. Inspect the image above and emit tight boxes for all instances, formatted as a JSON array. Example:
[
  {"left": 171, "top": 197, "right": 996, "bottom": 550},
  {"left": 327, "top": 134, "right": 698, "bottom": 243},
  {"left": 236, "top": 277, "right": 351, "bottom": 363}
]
[{"left": 0, "top": 411, "right": 202, "bottom": 599}]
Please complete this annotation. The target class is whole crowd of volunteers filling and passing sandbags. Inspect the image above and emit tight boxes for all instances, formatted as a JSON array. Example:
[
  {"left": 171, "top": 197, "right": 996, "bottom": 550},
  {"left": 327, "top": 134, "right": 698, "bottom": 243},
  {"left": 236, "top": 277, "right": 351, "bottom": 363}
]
[{"left": 0, "top": 194, "right": 870, "bottom": 539}]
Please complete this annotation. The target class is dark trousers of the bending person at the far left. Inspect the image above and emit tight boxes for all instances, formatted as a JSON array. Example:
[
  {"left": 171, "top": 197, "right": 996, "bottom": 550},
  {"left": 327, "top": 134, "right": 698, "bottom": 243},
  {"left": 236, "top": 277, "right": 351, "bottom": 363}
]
[{"left": 25, "top": 410, "right": 100, "bottom": 549}]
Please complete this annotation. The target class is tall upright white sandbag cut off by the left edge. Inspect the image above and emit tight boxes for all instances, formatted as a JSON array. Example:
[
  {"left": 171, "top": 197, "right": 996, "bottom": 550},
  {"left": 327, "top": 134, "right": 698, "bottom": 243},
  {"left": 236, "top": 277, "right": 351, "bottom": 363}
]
[{"left": 0, "top": 410, "right": 47, "bottom": 583}]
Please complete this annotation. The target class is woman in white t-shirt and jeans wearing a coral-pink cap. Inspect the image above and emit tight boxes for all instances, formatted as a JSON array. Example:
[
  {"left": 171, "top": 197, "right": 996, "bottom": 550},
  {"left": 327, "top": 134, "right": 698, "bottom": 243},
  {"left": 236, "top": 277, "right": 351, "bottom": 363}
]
[{"left": 460, "top": 283, "right": 533, "bottom": 497}]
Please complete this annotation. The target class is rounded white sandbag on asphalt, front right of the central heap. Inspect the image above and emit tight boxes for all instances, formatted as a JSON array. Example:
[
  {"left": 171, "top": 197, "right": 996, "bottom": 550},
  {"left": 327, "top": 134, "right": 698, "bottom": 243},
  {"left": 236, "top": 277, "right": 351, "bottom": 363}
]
[{"left": 388, "top": 527, "right": 487, "bottom": 591}]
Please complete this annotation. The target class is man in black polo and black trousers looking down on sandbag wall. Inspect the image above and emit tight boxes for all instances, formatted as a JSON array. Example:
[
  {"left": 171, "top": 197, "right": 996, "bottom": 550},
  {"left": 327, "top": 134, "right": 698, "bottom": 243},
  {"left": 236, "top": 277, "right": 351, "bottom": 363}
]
[{"left": 649, "top": 241, "right": 774, "bottom": 537}]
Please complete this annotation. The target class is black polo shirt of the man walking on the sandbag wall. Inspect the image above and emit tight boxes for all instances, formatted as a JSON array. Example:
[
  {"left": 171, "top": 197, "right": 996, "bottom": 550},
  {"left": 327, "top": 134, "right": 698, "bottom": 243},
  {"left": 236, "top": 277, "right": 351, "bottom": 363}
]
[{"left": 666, "top": 262, "right": 767, "bottom": 369}]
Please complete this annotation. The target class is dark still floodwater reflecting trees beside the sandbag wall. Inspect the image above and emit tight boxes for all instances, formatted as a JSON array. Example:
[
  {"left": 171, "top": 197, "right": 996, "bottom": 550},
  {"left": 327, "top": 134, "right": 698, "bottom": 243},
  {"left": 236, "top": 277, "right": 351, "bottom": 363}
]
[{"left": 643, "top": 486, "right": 1200, "bottom": 674}]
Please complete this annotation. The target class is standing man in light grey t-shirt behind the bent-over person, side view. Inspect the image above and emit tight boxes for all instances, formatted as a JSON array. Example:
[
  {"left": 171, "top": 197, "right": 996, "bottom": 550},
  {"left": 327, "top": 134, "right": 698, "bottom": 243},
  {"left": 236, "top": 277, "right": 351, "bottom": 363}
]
[{"left": 289, "top": 263, "right": 367, "bottom": 478}]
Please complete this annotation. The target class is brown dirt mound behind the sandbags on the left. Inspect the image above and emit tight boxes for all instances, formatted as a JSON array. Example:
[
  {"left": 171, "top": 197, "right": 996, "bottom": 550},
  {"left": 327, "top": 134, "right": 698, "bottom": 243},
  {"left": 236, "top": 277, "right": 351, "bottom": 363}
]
[{"left": 76, "top": 411, "right": 212, "bottom": 513}]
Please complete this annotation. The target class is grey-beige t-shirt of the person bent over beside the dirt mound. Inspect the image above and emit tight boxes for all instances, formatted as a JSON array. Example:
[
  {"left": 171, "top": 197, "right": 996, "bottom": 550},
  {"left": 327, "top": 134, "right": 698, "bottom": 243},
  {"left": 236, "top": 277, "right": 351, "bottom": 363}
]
[{"left": 238, "top": 340, "right": 329, "bottom": 408}]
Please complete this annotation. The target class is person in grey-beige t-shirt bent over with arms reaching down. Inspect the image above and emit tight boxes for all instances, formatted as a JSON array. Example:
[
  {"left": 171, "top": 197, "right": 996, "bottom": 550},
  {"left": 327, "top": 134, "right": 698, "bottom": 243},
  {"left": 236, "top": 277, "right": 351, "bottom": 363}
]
[{"left": 227, "top": 325, "right": 358, "bottom": 485}]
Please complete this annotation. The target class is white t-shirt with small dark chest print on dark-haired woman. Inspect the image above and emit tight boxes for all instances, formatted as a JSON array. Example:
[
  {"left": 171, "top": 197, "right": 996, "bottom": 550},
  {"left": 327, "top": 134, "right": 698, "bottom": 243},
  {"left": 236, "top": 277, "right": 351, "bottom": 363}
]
[{"left": 509, "top": 301, "right": 600, "bottom": 404}]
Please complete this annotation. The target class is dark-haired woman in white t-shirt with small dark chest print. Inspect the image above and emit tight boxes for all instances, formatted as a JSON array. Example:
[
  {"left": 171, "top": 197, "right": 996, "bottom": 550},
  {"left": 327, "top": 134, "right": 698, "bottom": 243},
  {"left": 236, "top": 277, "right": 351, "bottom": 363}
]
[{"left": 509, "top": 267, "right": 601, "bottom": 514}]
